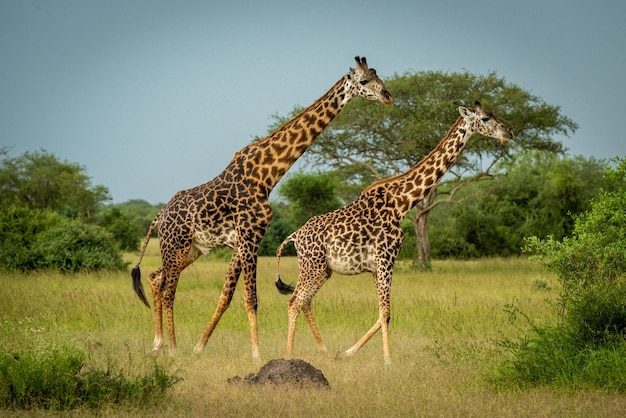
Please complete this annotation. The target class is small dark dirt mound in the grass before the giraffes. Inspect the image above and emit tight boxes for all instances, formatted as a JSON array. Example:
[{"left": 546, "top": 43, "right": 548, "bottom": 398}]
[{"left": 227, "top": 359, "right": 330, "bottom": 389}]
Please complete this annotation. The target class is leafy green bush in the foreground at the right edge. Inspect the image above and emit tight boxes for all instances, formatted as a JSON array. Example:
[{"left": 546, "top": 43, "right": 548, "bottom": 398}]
[{"left": 503, "top": 160, "right": 626, "bottom": 392}]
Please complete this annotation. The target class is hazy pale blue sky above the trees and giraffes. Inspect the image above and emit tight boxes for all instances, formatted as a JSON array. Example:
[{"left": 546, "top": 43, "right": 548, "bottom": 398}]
[{"left": 0, "top": 0, "right": 626, "bottom": 203}]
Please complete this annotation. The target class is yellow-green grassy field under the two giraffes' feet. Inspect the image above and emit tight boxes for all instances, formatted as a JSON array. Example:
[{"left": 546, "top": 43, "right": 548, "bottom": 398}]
[{"left": 0, "top": 240, "right": 626, "bottom": 417}]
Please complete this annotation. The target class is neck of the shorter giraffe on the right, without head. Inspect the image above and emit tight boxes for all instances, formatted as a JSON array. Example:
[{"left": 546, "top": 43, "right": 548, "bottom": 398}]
[{"left": 364, "top": 117, "right": 474, "bottom": 218}]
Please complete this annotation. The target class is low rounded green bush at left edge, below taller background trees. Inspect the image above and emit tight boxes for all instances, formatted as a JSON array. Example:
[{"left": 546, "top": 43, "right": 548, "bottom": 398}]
[{"left": 0, "top": 206, "right": 125, "bottom": 273}]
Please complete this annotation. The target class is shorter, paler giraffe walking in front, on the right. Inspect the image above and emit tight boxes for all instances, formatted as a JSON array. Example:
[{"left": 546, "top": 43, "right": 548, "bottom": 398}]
[{"left": 276, "top": 102, "right": 513, "bottom": 363}]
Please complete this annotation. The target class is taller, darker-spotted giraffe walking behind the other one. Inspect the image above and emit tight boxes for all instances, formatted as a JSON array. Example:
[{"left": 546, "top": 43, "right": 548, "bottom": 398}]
[{"left": 131, "top": 57, "right": 393, "bottom": 358}]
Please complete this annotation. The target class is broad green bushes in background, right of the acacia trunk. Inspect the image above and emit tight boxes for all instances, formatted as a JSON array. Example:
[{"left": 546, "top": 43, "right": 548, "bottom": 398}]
[{"left": 430, "top": 152, "right": 606, "bottom": 258}]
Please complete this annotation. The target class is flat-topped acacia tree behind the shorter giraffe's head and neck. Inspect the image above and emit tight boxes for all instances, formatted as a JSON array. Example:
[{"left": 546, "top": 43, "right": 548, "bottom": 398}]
[{"left": 268, "top": 71, "right": 578, "bottom": 268}]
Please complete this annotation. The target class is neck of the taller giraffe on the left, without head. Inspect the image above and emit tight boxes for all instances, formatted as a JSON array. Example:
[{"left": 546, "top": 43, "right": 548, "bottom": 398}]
[{"left": 238, "top": 76, "right": 353, "bottom": 190}]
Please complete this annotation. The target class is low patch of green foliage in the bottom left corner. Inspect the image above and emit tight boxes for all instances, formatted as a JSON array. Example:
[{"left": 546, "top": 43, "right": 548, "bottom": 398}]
[{"left": 0, "top": 348, "right": 180, "bottom": 411}]
